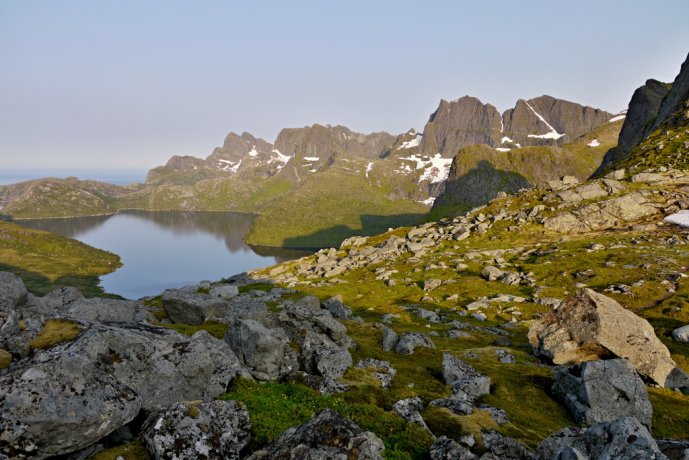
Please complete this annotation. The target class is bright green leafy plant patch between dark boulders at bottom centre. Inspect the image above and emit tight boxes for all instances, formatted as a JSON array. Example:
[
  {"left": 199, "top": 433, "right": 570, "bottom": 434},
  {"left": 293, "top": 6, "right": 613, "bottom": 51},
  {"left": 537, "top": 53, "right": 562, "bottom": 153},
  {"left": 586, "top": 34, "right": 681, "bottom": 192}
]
[{"left": 220, "top": 380, "right": 433, "bottom": 459}]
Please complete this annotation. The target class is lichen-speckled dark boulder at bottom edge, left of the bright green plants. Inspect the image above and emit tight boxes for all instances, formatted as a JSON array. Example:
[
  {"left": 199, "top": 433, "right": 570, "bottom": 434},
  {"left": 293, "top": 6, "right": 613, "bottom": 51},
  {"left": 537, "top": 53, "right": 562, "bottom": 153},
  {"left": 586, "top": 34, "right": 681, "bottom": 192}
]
[{"left": 141, "top": 400, "right": 251, "bottom": 460}]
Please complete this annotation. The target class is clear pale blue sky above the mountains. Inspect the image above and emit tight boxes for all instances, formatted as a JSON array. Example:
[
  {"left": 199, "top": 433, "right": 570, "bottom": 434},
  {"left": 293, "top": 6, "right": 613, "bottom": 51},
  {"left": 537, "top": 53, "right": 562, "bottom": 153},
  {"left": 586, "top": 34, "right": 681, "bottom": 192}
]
[{"left": 0, "top": 0, "right": 689, "bottom": 169}]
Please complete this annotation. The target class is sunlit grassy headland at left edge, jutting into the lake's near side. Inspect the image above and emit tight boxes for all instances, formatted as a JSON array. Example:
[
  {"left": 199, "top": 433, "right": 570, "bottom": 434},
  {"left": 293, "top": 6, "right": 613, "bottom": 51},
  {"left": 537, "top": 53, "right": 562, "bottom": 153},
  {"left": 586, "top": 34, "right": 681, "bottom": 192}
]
[{"left": 0, "top": 222, "right": 120, "bottom": 296}]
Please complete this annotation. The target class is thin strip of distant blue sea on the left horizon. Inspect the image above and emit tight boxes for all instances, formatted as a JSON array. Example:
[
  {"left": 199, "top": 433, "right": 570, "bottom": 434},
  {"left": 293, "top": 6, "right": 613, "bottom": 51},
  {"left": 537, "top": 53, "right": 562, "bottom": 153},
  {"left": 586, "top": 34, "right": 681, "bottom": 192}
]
[{"left": 0, "top": 168, "right": 146, "bottom": 185}]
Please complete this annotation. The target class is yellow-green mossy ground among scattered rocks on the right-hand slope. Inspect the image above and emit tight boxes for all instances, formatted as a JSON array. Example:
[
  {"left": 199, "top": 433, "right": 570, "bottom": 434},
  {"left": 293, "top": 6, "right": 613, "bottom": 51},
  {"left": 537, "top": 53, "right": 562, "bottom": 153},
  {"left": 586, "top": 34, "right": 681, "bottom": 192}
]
[{"left": 250, "top": 178, "right": 689, "bottom": 447}]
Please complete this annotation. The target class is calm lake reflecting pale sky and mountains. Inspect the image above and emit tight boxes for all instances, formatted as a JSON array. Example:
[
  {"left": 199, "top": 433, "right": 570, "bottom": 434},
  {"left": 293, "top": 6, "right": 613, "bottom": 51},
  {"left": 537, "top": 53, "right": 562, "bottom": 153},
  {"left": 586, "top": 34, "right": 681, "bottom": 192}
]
[{"left": 15, "top": 211, "right": 309, "bottom": 299}]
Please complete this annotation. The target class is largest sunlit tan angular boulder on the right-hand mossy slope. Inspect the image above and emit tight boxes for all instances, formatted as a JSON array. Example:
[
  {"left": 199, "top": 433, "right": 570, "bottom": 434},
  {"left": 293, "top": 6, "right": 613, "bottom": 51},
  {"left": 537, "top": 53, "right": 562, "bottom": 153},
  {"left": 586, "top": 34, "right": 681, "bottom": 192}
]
[{"left": 529, "top": 289, "right": 689, "bottom": 388}]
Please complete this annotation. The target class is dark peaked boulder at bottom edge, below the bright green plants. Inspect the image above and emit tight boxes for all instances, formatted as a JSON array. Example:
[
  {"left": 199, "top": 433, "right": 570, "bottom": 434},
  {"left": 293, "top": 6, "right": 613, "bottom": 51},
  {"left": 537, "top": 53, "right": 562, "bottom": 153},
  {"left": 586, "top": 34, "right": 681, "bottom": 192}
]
[{"left": 249, "top": 409, "right": 385, "bottom": 460}]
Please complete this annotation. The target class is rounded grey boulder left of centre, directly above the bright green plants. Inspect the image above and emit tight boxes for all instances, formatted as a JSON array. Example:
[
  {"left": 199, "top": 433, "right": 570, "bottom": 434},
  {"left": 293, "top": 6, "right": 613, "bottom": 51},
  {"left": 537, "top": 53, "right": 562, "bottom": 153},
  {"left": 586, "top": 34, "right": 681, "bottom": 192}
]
[{"left": 225, "top": 319, "right": 297, "bottom": 380}]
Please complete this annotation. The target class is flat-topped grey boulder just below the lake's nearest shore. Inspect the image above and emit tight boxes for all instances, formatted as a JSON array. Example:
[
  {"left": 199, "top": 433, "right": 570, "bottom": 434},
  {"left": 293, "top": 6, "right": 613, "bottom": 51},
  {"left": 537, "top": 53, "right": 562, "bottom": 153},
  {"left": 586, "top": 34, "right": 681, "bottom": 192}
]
[{"left": 162, "top": 289, "right": 227, "bottom": 325}]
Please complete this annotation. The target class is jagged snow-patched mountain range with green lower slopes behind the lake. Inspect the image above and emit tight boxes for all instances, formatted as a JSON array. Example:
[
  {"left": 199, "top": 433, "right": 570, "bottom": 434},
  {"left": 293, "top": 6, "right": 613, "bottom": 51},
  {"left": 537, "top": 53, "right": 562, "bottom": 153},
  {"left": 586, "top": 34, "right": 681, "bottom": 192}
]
[{"left": 0, "top": 92, "right": 624, "bottom": 247}]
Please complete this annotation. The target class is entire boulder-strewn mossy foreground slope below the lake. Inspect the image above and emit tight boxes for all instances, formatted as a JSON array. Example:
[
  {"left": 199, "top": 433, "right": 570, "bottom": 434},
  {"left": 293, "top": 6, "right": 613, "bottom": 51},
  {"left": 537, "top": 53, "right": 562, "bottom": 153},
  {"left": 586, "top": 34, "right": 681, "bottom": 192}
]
[{"left": 0, "top": 168, "right": 689, "bottom": 459}]
